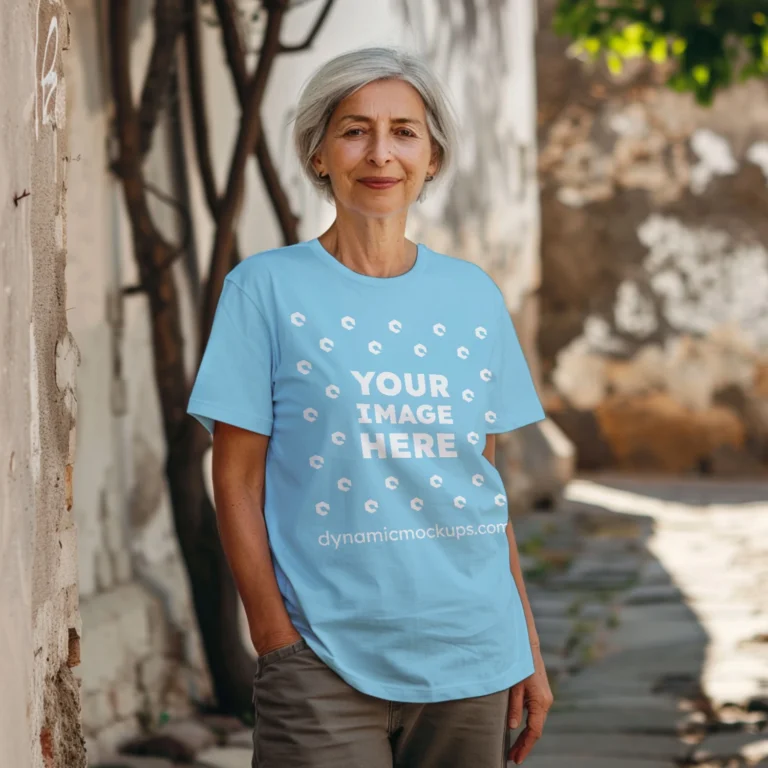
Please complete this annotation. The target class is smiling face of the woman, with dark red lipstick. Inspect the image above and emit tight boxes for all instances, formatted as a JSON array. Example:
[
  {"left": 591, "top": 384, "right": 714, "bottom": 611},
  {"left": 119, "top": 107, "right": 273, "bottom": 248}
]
[{"left": 313, "top": 80, "right": 438, "bottom": 218}]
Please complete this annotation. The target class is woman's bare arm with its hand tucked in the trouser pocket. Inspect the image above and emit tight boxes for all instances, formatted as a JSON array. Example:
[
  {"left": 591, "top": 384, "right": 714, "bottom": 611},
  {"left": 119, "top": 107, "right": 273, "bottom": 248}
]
[{"left": 213, "top": 422, "right": 300, "bottom": 655}]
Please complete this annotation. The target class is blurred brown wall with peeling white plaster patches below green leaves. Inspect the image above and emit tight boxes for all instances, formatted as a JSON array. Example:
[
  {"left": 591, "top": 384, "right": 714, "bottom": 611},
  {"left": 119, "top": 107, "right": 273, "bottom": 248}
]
[{"left": 536, "top": 0, "right": 768, "bottom": 474}]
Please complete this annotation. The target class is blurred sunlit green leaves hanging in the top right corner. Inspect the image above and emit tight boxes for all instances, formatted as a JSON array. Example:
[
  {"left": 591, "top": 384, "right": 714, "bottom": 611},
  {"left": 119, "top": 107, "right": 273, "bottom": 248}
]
[{"left": 554, "top": 0, "right": 768, "bottom": 104}]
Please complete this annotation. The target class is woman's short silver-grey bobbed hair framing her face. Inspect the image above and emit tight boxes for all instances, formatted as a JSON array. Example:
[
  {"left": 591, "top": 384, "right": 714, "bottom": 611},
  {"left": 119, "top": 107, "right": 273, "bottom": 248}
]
[{"left": 293, "top": 47, "right": 458, "bottom": 200}]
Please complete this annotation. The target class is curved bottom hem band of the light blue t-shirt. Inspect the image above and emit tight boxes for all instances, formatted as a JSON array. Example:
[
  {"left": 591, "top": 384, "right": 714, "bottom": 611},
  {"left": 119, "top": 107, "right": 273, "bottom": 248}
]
[{"left": 305, "top": 638, "right": 535, "bottom": 704}]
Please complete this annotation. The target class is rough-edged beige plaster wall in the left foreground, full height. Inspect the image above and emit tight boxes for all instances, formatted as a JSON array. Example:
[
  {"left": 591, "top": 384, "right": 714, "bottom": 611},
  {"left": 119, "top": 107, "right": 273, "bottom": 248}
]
[{"left": 0, "top": 0, "right": 85, "bottom": 768}]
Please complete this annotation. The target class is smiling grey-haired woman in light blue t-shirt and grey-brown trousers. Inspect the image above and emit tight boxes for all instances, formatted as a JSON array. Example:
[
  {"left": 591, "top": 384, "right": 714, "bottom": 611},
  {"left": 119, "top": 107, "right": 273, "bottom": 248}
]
[{"left": 189, "top": 48, "right": 552, "bottom": 768}]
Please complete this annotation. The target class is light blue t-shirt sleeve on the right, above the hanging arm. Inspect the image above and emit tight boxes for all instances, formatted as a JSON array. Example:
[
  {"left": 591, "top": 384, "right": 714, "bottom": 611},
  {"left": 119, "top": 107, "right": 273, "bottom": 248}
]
[{"left": 486, "top": 300, "right": 546, "bottom": 434}]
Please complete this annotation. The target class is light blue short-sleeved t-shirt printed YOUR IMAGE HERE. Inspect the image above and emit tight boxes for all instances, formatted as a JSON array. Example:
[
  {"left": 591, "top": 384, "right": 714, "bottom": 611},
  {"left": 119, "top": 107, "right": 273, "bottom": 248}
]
[{"left": 189, "top": 240, "right": 544, "bottom": 703}]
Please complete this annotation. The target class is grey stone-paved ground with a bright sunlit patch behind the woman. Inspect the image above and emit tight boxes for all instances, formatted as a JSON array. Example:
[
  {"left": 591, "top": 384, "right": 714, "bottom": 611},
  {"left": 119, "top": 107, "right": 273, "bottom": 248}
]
[{"left": 94, "top": 476, "right": 768, "bottom": 768}]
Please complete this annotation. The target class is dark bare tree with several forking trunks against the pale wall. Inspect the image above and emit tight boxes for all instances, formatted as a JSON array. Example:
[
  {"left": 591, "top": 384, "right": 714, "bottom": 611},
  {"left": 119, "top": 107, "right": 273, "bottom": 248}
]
[{"left": 109, "top": 0, "right": 334, "bottom": 715}]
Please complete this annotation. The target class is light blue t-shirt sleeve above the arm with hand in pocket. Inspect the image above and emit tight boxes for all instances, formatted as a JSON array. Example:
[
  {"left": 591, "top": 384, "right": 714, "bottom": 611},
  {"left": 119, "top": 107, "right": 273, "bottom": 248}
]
[{"left": 187, "top": 280, "right": 273, "bottom": 435}]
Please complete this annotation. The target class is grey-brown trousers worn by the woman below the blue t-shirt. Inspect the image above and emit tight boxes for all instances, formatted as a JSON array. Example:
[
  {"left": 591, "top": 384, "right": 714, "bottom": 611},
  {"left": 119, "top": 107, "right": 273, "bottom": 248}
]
[{"left": 252, "top": 640, "right": 509, "bottom": 768}]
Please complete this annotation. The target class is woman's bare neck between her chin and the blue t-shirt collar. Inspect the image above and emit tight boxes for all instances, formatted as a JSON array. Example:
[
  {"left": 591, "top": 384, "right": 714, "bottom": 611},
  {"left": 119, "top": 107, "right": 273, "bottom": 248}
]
[{"left": 318, "top": 215, "right": 417, "bottom": 277}]
